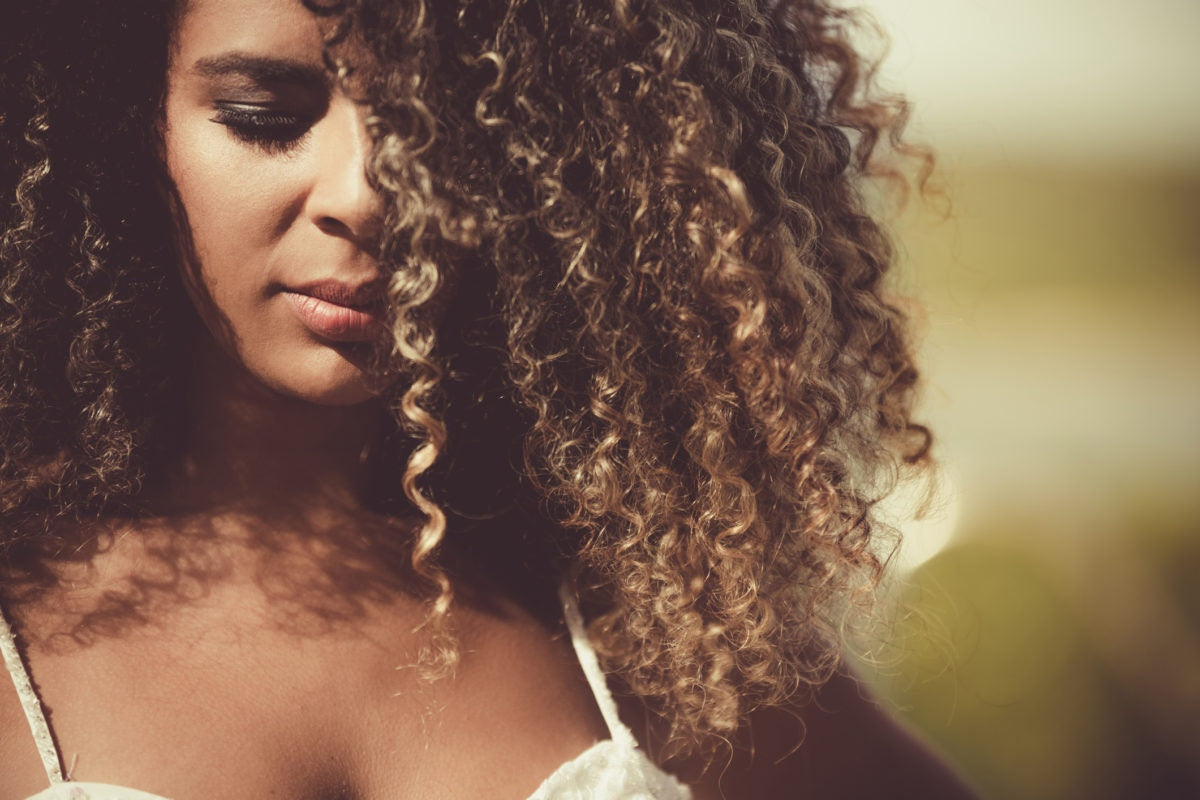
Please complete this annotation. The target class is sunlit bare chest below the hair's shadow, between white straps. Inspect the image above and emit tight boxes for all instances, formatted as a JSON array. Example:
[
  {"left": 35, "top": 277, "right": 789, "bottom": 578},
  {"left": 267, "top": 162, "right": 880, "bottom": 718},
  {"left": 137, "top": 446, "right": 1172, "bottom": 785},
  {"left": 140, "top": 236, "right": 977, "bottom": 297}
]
[{"left": 0, "top": 594, "right": 607, "bottom": 800}]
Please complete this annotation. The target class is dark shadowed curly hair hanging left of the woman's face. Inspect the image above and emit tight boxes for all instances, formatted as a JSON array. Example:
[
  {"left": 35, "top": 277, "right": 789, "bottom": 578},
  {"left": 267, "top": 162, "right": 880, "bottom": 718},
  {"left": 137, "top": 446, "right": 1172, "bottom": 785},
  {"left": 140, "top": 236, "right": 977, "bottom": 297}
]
[{"left": 0, "top": 1, "right": 190, "bottom": 544}]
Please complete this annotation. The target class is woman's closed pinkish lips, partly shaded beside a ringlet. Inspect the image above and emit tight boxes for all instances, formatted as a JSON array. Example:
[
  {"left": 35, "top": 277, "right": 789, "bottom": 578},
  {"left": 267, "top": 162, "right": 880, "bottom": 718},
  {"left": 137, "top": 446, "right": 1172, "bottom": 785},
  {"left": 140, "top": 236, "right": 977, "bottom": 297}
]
[{"left": 283, "top": 281, "right": 384, "bottom": 342}]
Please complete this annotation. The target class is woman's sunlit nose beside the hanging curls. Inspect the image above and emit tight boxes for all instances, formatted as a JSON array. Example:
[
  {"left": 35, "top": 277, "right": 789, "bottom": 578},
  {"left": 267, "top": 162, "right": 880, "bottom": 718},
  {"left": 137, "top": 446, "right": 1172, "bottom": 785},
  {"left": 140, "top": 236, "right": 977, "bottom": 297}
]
[{"left": 306, "top": 96, "right": 383, "bottom": 249}]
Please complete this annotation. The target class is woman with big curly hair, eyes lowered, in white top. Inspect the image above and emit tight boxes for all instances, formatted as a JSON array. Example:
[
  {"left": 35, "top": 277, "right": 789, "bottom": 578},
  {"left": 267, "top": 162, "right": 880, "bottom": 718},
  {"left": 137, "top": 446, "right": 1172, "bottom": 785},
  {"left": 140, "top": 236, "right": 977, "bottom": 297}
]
[{"left": 0, "top": 0, "right": 965, "bottom": 800}]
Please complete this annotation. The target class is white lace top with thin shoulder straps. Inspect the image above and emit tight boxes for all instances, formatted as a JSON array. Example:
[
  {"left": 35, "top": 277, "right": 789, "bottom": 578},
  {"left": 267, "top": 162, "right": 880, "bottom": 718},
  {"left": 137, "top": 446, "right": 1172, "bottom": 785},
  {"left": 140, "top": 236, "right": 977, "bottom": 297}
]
[{"left": 0, "top": 587, "right": 691, "bottom": 800}]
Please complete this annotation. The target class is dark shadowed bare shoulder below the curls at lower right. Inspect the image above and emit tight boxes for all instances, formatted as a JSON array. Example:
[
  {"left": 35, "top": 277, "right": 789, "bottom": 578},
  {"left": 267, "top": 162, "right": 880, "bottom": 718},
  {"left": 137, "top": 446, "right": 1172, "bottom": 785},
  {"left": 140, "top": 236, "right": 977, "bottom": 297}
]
[{"left": 695, "top": 673, "right": 978, "bottom": 800}]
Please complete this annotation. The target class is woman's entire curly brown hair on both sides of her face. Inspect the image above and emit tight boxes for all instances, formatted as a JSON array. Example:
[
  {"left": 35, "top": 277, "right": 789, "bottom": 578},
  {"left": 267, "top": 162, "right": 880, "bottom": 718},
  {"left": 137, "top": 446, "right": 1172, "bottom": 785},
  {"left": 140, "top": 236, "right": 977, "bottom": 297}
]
[{"left": 0, "top": 0, "right": 929, "bottom": 753}]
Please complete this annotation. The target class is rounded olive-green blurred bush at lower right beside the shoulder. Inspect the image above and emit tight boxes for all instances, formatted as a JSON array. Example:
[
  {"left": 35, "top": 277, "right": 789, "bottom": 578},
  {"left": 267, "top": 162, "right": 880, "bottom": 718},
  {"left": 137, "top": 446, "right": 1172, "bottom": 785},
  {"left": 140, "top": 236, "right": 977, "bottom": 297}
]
[{"left": 876, "top": 542, "right": 1200, "bottom": 800}]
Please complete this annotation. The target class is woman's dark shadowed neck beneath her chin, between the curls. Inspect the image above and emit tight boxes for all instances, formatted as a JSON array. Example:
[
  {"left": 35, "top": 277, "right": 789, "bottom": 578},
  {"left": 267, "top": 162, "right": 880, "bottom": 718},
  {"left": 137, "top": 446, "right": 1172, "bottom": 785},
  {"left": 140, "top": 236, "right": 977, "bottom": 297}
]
[{"left": 154, "top": 338, "right": 384, "bottom": 513}]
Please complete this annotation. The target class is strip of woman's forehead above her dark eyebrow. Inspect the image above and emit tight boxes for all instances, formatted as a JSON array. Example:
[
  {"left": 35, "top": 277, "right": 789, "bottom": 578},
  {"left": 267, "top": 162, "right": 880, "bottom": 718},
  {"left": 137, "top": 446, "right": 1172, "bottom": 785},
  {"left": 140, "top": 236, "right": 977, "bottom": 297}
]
[{"left": 172, "top": 0, "right": 323, "bottom": 70}]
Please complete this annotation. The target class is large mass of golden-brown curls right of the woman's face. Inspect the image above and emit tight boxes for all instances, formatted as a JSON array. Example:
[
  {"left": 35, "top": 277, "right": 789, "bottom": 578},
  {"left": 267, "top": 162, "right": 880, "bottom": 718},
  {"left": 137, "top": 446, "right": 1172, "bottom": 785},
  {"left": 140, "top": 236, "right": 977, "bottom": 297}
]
[{"left": 348, "top": 0, "right": 928, "bottom": 751}]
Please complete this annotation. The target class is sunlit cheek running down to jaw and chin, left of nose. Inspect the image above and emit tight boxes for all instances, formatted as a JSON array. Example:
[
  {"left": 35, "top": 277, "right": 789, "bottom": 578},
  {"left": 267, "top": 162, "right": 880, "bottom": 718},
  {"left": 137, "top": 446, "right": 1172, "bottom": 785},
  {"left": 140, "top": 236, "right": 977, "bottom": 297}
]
[{"left": 163, "top": 95, "right": 372, "bottom": 404}]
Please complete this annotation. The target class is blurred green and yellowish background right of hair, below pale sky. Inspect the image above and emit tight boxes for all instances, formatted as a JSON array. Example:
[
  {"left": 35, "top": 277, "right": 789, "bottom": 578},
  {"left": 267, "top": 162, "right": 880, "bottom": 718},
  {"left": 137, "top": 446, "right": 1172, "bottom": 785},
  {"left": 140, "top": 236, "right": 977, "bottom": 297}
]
[{"left": 871, "top": 156, "right": 1200, "bottom": 800}]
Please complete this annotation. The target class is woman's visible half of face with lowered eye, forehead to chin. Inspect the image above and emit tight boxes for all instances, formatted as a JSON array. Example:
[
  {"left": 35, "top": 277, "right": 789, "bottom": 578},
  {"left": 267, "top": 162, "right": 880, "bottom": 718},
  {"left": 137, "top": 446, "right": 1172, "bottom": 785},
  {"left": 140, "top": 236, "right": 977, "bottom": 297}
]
[{"left": 164, "top": 0, "right": 383, "bottom": 404}]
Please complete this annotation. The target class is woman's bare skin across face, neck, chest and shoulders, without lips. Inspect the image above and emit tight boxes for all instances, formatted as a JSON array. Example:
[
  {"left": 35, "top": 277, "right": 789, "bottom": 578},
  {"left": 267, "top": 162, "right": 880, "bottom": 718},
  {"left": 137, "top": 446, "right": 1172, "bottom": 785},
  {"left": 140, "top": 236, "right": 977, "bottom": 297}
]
[{"left": 0, "top": 0, "right": 984, "bottom": 800}]
